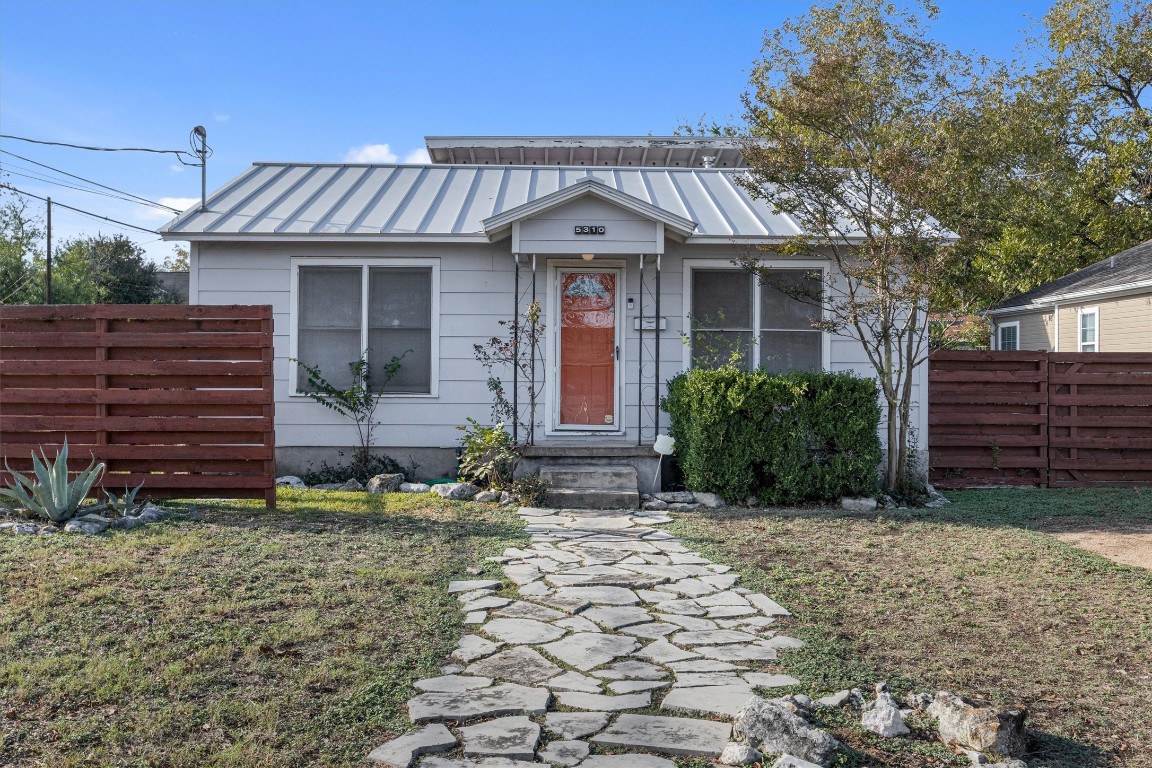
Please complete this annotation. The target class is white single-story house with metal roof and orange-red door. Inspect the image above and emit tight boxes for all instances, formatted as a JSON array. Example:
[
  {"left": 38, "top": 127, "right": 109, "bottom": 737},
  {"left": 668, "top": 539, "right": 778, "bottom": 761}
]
[{"left": 161, "top": 137, "right": 926, "bottom": 478}]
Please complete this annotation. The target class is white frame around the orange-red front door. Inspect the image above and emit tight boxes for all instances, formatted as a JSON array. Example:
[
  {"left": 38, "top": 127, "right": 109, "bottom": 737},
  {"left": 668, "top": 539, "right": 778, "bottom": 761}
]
[{"left": 544, "top": 257, "right": 628, "bottom": 435}]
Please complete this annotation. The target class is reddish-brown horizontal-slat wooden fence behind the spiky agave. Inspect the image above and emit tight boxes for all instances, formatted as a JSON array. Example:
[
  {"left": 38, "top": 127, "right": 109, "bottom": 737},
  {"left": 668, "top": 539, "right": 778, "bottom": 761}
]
[{"left": 0, "top": 304, "right": 275, "bottom": 508}]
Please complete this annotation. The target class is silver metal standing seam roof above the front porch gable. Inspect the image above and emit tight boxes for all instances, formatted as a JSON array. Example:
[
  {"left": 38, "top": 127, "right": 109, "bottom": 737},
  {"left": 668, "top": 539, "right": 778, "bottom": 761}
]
[{"left": 160, "top": 162, "right": 802, "bottom": 241}]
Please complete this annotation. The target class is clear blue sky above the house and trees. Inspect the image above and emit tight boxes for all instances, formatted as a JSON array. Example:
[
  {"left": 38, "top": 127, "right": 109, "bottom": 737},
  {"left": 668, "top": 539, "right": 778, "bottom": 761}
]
[{"left": 0, "top": 0, "right": 1049, "bottom": 264}]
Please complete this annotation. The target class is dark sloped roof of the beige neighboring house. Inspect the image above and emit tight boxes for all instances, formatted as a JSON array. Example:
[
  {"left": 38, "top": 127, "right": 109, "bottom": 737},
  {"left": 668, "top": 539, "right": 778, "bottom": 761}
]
[{"left": 987, "top": 239, "right": 1152, "bottom": 314}]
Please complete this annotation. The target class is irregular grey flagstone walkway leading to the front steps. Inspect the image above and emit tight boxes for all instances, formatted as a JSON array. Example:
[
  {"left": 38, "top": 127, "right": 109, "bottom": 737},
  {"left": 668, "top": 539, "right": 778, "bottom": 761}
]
[{"left": 369, "top": 507, "right": 801, "bottom": 768}]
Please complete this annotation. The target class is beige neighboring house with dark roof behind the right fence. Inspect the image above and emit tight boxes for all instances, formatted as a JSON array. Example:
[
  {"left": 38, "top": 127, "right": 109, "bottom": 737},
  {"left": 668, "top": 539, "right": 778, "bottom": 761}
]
[{"left": 985, "top": 241, "right": 1152, "bottom": 352}]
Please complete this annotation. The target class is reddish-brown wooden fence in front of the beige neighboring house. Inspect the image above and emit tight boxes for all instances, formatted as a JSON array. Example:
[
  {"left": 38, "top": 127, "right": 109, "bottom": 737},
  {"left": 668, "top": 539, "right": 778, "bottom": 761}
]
[{"left": 929, "top": 351, "right": 1152, "bottom": 488}]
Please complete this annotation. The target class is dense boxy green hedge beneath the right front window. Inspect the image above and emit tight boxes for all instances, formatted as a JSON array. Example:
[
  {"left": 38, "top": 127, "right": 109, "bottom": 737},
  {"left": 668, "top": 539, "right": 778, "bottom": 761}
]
[{"left": 661, "top": 366, "right": 881, "bottom": 504}]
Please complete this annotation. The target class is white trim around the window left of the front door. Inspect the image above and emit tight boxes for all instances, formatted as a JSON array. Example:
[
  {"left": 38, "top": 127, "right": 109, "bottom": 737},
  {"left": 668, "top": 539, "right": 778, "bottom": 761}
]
[{"left": 288, "top": 257, "right": 440, "bottom": 400}]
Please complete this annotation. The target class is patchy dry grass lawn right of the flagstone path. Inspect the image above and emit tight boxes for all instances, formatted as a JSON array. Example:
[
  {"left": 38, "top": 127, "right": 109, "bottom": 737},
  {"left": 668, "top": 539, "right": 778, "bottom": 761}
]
[{"left": 669, "top": 489, "right": 1152, "bottom": 768}]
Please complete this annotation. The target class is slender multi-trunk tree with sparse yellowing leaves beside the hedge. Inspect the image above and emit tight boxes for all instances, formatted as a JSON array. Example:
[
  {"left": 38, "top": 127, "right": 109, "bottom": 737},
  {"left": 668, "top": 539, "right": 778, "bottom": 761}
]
[{"left": 740, "top": 0, "right": 977, "bottom": 491}]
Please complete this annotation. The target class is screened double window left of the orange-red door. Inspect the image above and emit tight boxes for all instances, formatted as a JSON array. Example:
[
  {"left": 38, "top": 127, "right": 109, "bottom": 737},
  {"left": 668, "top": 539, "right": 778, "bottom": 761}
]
[{"left": 295, "top": 263, "right": 438, "bottom": 394}]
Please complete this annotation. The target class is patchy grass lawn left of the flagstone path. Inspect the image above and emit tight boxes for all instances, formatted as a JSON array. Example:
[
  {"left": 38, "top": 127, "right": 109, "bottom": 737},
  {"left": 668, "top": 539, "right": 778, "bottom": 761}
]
[{"left": 0, "top": 491, "right": 523, "bottom": 768}]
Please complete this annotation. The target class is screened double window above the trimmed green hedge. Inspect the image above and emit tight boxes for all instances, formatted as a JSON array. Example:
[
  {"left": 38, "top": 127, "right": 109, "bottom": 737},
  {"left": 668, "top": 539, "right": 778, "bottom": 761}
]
[{"left": 689, "top": 267, "right": 824, "bottom": 373}]
